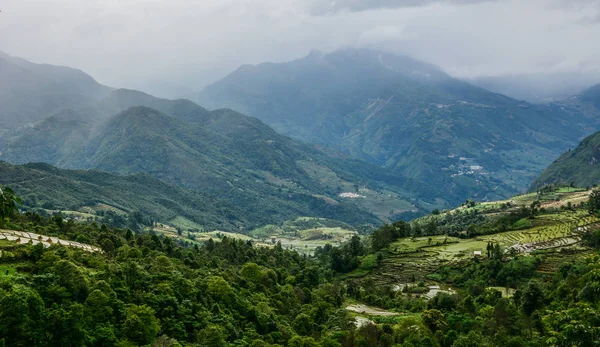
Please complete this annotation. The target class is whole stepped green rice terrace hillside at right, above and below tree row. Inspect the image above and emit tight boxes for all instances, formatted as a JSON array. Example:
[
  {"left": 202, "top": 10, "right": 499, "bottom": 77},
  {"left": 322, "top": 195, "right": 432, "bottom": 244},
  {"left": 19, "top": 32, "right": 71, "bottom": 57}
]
[{"left": 348, "top": 188, "right": 600, "bottom": 290}]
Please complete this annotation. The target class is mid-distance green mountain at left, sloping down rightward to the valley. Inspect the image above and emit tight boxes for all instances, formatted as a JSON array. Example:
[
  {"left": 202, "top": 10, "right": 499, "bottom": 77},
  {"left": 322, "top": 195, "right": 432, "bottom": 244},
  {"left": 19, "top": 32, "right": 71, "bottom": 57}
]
[{"left": 0, "top": 99, "right": 439, "bottom": 227}]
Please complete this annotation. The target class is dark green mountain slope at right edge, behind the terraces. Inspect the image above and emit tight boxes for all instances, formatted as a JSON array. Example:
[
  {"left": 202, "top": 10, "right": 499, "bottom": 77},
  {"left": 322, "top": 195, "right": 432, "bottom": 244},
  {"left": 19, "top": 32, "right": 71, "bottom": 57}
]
[{"left": 530, "top": 132, "right": 600, "bottom": 191}]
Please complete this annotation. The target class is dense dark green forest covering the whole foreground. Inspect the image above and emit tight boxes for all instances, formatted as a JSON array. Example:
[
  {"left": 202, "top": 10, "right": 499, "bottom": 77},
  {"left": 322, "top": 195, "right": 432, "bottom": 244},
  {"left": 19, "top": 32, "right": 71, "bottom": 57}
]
[{"left": 0, "top": 187, "right": 600, "bottom": 347}]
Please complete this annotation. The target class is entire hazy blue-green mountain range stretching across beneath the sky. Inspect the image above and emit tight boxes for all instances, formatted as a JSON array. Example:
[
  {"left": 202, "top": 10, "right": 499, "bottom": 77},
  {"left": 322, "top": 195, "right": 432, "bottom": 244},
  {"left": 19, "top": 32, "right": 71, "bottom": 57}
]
[{"left": 0, "top": 49, "right": 598, "bottom": 230}]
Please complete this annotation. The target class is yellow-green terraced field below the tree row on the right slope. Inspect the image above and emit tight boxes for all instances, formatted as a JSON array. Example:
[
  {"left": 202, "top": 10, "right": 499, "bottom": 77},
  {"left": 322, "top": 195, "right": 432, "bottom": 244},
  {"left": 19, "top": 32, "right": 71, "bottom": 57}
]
[{"left": 369, "top": 210, "right": 600, "bottom": 285}]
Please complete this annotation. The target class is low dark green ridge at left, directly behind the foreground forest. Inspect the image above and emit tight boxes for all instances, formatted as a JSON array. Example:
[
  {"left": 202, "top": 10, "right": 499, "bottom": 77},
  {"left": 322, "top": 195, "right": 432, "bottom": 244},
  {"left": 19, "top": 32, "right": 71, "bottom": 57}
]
[{"left": 0, "top": 162, "right": 249, "bottom": 230}]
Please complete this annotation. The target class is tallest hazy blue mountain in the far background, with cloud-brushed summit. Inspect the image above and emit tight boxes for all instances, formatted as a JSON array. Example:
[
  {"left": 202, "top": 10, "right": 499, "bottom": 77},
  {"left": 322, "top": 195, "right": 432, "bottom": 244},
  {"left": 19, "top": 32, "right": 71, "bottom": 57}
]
[{"left": 198, "top": 49, "right": 597, "bottom": 203}]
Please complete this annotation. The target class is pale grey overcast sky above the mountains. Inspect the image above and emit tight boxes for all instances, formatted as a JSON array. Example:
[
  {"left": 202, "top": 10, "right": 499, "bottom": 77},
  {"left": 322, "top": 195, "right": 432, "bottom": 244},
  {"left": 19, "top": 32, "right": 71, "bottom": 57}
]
[{"left": 0, "top": 0, "right": 600, "bottom": 90}]
